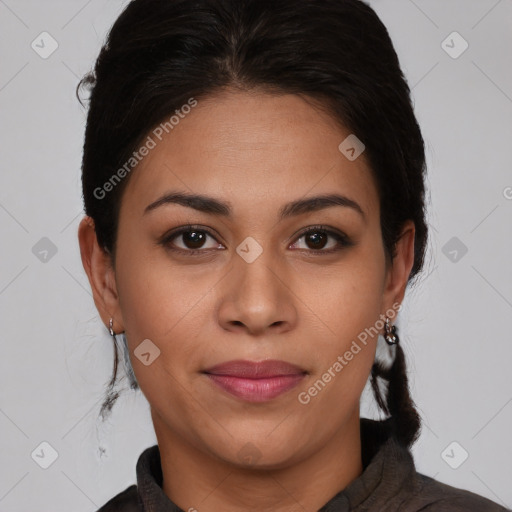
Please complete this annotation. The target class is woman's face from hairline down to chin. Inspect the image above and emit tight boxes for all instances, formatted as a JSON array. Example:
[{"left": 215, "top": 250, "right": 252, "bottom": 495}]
[{"left": 82, "top": 87, "right": 412, "bottom": 467}]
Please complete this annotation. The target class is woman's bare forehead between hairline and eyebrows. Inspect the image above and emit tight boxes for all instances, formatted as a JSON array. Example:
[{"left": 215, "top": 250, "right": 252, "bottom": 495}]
[{"left": 119, "top": 91, "right": 378, "bottom": 221}]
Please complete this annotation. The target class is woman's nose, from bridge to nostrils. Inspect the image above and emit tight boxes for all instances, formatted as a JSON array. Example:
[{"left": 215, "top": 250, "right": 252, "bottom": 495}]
[{"left": 218, "top": 251, "right": 297, "bottom": 336}]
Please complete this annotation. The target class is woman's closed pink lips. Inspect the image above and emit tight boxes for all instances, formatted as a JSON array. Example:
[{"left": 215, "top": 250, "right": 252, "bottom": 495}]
[{"left": 204, "top": 360, "right": 307, "bottom": 402}]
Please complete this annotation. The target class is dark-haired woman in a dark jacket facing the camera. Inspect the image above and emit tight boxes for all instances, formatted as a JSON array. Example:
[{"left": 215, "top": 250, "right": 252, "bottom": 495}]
[{"left": 75, "top": 0, "right": 505, "bottom": 512}]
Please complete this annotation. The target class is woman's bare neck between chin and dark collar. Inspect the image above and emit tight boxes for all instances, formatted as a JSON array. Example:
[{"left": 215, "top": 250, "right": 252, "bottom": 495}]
[{"left": 153, "top": 411, "right": 363, "bottom": 512}]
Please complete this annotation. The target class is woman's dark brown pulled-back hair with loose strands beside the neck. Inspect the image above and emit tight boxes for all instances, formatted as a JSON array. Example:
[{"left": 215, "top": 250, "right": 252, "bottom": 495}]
[{"left": 79, "top": 0, "right": 427, "bottom": 446}]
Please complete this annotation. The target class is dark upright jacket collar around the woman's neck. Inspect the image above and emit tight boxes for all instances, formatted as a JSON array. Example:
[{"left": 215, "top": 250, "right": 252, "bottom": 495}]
[{"left": 136, "top": 418, "right": 416, "bottom": 512}]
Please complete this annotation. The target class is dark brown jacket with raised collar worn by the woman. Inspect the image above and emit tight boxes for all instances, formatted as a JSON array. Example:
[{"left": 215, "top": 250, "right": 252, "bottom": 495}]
[{"left": 98, "top": 418, "right": 510, "bottom": 512}]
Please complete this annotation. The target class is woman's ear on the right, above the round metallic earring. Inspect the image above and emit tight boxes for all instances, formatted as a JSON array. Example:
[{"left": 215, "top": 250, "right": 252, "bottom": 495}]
[{"left": 382, "top": 220, "right": 416, "bottom": 312}]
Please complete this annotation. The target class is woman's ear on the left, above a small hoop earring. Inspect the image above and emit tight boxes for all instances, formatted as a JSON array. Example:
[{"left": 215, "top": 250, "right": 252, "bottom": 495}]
[{"left": 78, "top": 216, "right": 124, "bottom": 333}]
